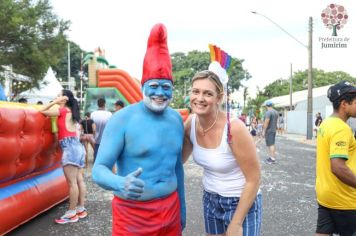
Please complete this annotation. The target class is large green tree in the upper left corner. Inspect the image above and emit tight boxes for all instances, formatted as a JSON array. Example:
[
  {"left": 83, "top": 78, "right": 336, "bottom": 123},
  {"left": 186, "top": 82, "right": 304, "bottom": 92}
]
[{"left": 0, "top": 0, "right": 69, "bottom": 95}]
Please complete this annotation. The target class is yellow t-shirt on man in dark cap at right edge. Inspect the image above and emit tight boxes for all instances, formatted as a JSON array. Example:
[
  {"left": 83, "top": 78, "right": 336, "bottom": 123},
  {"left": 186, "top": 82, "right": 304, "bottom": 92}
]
[{"left": 315, "top": 117, "right": 356, "bottom": 210}]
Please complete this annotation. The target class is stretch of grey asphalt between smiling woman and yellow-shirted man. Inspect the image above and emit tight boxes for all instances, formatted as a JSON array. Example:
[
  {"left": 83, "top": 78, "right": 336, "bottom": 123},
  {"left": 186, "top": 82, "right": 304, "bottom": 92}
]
[{"left": 259, "top": 134, "right": 317, "bottom": 236}]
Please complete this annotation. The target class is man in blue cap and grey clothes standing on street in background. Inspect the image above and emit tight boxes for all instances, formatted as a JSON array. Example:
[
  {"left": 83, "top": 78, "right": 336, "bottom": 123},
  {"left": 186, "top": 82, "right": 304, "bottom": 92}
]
[{"left": 262, "top": 101, "right": 278, "bottom": 164}]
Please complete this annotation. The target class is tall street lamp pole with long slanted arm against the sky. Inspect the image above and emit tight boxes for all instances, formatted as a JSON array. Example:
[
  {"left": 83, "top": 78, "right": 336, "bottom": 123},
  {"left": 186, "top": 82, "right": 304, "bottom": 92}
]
[{"left": 251, "top": 11, "right": 313, "bottom": 139}]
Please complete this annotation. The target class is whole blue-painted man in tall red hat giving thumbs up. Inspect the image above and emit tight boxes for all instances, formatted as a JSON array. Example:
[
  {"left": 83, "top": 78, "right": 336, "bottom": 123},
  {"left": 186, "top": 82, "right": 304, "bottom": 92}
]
[{"left": 93, "top": 24, "right": 185, "bottom": 235}]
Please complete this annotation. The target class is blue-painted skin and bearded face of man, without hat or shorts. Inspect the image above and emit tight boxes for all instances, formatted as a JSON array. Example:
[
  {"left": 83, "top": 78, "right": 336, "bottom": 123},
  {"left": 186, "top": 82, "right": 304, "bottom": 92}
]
[{"left": 92, "top": 79, "right": 186, "bottom": 228}]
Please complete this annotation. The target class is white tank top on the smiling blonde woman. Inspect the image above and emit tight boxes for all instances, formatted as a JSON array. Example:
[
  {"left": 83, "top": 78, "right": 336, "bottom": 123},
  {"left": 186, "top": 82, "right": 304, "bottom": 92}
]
[{"left": 190, "top": 114, "right": 246, "bottom": 197}]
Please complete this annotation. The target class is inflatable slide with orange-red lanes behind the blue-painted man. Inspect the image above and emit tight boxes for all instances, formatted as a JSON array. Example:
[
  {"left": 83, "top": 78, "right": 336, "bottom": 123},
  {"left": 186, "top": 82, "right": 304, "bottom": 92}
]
[{"left": 83, "top": 48, "right": 189, "bottom": 120}]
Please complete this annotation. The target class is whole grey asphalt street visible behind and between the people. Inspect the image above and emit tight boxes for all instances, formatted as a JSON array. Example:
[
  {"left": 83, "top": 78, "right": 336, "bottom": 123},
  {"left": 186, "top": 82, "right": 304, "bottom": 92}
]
[{"left": 9, "top": 135, "right": 317, "bottom": 236}]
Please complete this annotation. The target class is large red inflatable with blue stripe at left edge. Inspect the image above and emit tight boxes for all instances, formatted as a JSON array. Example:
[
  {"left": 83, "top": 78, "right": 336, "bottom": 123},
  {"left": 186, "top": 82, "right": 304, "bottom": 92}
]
[{"left": 0, "top": 101, "right": 69, "bottom": 235}]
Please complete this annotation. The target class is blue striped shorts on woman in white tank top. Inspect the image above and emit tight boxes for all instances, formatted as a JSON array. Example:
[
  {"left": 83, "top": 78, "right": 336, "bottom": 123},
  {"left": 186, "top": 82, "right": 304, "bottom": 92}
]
[{"left": 203, "top": 191, "right": 262, "bottom": 236}]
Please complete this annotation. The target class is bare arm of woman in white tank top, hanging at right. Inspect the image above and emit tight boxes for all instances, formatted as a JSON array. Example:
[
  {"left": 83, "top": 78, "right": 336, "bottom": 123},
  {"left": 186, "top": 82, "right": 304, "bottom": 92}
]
[{"left": 227, "top": 120, "right": 261, "bottom": 235}]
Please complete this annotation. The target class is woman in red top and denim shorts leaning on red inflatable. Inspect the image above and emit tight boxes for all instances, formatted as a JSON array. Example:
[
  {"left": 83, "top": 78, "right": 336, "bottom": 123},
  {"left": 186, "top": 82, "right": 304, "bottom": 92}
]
[{"left": 40, "top": 89, "right": 87, "bottom": 224}]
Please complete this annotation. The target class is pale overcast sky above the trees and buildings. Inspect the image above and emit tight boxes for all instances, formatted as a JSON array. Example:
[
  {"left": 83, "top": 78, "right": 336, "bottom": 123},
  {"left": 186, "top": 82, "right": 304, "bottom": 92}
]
[{"left": 50, "top": 0, "right": 356, "bottom": 101}]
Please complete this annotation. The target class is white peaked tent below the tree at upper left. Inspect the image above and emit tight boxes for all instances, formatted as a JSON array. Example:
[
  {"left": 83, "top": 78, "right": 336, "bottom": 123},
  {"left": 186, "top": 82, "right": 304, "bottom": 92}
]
[{"left": 18, "top": 67, "right": 63, "bottom": 104}]
